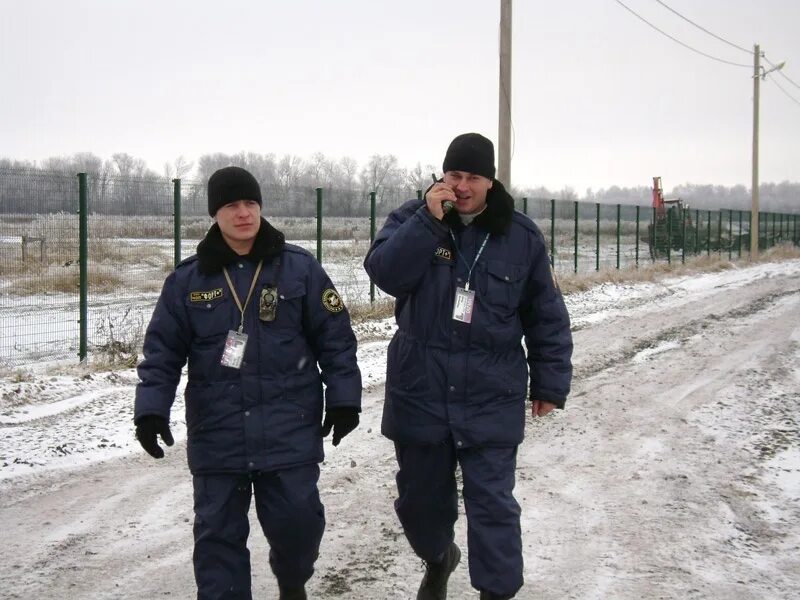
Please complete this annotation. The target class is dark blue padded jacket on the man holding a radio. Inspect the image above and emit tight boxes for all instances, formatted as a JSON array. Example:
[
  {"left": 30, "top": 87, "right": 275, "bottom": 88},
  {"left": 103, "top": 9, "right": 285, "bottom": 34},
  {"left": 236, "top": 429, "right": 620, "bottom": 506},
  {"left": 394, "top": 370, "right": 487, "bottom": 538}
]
[{"left": 364, "top": 180, "right": 572, "bottom": 447}]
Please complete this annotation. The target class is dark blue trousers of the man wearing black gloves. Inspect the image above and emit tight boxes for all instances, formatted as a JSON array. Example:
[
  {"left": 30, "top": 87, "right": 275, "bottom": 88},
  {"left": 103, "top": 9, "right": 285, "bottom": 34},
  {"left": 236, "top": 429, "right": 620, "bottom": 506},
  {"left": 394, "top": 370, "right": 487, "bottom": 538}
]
[{"left": 193, "top": 464, "right": 325, "bottom": 600}]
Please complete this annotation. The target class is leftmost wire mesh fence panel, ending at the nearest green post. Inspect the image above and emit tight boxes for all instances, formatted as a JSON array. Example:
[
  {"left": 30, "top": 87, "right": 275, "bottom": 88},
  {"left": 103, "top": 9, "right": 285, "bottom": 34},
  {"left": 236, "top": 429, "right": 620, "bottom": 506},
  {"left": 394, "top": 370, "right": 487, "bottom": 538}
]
[{"left": 0, "top": 172, "right": 79, "bottom": 367}]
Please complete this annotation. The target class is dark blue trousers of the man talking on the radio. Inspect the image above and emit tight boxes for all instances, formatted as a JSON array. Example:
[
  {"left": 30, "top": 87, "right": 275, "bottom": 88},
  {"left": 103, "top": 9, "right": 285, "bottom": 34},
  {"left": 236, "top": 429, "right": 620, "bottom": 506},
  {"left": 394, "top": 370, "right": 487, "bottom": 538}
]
[{"left": 395, "top": 439, "right": 523, "bottom": 595}]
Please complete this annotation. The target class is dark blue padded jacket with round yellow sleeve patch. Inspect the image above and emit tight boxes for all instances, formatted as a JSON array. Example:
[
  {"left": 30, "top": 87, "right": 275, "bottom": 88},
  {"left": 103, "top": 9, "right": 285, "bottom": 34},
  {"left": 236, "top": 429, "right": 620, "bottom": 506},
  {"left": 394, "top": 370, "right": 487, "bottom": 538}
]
[{"left": 134, "top": 219, "right": 361, "bottom": 475}]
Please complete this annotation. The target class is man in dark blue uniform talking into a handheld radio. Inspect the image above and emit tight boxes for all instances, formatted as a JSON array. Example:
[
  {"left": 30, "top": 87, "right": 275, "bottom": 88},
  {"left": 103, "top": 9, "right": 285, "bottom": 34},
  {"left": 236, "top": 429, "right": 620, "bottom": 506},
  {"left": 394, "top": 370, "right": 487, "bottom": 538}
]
[{"left": 364, "top": 133, "right": 572, "bottom": 600}]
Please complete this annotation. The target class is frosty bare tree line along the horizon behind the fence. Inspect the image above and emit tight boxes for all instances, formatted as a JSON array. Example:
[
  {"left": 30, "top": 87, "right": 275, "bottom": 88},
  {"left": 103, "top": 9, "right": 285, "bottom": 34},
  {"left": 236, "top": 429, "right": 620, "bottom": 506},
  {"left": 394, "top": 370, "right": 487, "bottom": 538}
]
[{"left": 0, "top": 152, "right": 800, "bottom": 216}]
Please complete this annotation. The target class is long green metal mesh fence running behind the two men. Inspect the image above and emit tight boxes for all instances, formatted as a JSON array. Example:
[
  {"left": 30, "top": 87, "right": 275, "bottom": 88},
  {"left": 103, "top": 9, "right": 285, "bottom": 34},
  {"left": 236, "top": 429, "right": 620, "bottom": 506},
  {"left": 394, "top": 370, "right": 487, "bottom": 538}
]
[{"left": 0, "top": 170, "right": 800, "bottom": 368}]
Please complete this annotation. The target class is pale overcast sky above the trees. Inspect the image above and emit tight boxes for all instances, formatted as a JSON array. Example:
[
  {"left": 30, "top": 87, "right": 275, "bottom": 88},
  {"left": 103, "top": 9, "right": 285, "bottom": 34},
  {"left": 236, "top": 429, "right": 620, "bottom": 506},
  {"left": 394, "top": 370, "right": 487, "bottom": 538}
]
[{"left": 0, "top": 0, "right": 800, "bottom": 195}]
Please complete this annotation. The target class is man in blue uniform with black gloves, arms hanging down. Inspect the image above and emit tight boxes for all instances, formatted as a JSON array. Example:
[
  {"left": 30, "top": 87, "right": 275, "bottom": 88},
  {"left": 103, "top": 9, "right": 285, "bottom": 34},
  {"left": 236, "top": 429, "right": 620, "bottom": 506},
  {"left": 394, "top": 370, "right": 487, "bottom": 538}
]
[{"left": 134, "top": 167, "right": 361, "bottom": 600}]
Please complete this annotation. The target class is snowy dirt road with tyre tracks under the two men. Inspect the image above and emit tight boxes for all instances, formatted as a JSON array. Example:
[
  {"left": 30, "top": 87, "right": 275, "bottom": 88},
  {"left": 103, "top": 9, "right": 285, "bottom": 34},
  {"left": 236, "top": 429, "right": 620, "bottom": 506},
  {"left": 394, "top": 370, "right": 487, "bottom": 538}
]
[{"left": 0, "top": 260, "right": 800, "bottom": 600}]
